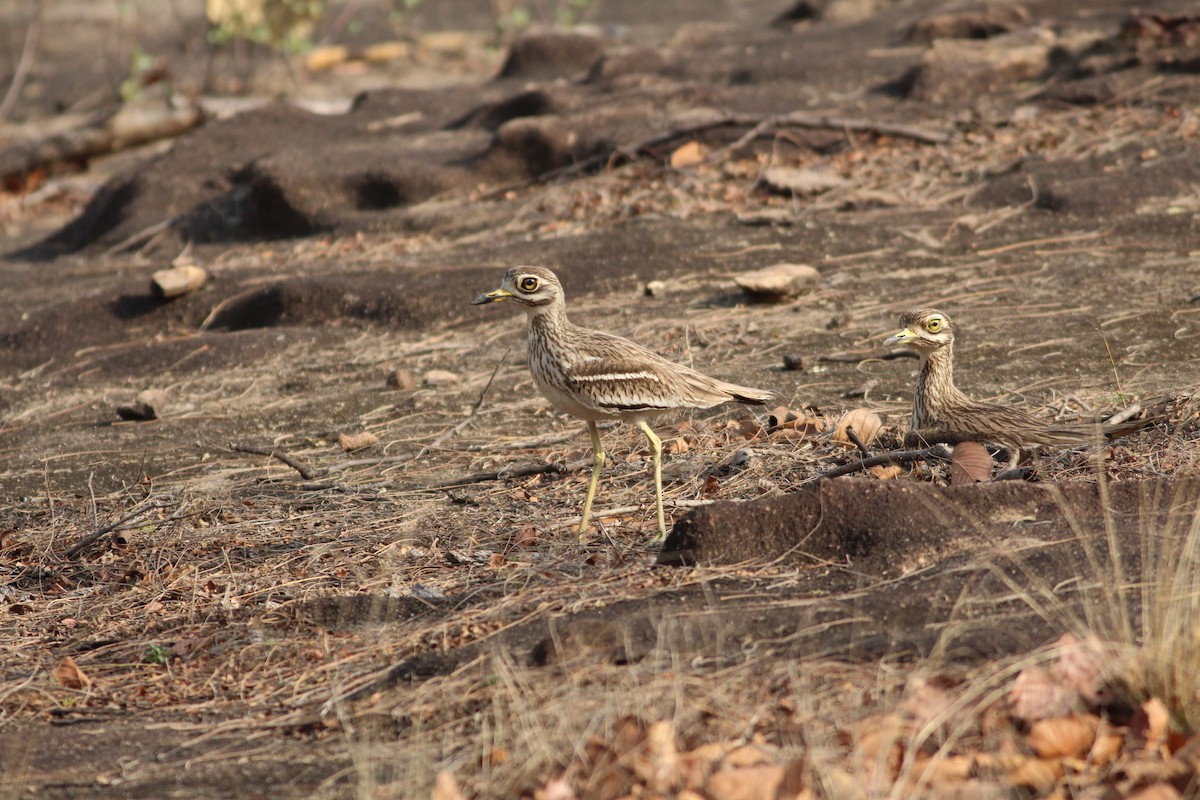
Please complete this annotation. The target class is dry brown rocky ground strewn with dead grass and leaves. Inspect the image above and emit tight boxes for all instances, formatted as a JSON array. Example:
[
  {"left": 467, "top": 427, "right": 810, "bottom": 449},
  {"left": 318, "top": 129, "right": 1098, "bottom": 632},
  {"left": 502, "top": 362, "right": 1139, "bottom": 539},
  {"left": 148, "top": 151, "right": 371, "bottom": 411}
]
[{"left": 0, "top": 0, "right": 1200, "bottom": 800}]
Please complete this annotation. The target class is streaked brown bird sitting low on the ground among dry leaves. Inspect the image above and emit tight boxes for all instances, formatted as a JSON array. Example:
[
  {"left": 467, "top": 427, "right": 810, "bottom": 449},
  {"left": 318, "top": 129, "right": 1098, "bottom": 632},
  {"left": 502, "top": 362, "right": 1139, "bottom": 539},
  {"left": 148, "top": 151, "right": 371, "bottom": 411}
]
[{"left": 883, "top": 308, "right": 1146, "bottom": 469}]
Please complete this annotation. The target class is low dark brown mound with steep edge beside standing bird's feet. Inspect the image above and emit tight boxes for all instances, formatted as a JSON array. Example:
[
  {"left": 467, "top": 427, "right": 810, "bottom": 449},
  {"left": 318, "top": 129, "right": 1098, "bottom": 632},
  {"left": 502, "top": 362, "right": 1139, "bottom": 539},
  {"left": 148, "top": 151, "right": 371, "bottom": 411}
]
[{"left": 659, "top": 479, "right": 1196, "bottom": 566}]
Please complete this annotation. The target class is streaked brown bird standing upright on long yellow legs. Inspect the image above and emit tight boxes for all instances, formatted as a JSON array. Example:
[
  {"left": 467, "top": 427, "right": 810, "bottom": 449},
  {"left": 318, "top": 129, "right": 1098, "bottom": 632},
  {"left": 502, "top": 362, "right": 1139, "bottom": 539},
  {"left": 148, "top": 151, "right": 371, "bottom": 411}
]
[{"left": 472, "top": 266, "right": 774, "bottom": 540}]
